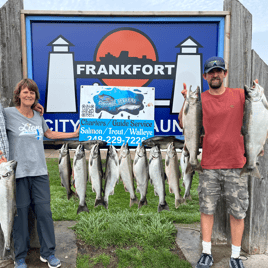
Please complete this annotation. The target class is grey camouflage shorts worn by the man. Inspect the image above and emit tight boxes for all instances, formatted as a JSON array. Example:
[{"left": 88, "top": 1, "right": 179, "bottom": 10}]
[{"left": 198, "top": 169, "right": 249, "bottom": 219}]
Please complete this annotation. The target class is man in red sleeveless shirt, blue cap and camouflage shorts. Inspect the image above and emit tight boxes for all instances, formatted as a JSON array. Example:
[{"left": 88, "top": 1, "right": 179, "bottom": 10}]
[{"left": 179, "top": 57, "right": 249, "bottom": 268}]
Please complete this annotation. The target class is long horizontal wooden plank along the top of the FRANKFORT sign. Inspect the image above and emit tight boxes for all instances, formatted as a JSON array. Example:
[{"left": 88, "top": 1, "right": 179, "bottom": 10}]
[{"left": 21, "top": 10, "right": 230, "bottom": 17}]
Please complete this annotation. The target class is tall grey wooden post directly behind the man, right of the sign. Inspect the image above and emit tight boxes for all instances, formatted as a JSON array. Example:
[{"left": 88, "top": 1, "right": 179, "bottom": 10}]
[{"left": 212, "top": 0, "right": 252, "bottom": 244}]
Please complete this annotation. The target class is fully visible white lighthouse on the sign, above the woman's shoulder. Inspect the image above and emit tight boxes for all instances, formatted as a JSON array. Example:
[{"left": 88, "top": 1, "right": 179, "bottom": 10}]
[{"left": 45, "top": 35, "right": 77, "bottom": 113}]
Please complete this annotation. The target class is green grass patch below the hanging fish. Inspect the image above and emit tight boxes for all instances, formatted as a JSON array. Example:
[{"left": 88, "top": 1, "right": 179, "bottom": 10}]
[{"left": 47, "top": 159, "right": 200, "bottom": 268}]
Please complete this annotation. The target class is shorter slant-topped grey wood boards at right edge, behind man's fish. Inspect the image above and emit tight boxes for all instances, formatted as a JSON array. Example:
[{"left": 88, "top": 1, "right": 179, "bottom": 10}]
[{"left": 242, "top": 50, "right": 268, "bottom": 254}]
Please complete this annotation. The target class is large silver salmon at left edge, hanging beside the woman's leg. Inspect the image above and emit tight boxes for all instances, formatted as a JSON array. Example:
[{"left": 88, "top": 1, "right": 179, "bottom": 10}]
[{"left": 0, "top": 160, "right": 17, "bottom": 257}]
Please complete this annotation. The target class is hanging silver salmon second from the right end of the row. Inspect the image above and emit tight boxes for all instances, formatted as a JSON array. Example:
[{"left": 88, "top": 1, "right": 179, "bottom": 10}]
[{"left": 165, "top": 142, "right": 184, "bottom": 208}]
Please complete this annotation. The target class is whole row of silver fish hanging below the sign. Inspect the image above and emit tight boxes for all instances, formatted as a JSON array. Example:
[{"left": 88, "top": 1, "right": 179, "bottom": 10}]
[{"left": 59, "top": 142, "right": 193, "bottom": 214}]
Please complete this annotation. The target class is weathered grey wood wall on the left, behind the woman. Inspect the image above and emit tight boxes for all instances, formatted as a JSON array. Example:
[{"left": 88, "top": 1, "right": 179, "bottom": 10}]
[{"left": 0, "top": 0, "right": 23, "bottom": 259}]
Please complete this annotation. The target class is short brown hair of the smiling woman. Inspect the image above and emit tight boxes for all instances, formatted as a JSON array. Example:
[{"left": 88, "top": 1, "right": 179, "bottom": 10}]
[{"left": 13, "top": 78, "right": 40, "bottom": 108}]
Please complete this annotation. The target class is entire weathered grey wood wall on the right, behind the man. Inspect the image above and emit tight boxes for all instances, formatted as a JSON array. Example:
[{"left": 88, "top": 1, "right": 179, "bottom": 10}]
[{"left": 212, "top": 0, "right": 268, "bottom": 254}]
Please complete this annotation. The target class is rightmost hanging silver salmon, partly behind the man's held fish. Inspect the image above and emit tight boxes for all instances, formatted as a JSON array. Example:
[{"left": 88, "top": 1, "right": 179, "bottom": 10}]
[{"left": 180, "top": 148, "right": 195, "bottom": 200}]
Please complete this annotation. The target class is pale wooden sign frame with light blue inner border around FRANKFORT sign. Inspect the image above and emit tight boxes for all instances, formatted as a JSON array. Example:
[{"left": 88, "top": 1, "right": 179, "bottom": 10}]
[{"left": 21, "top": 10, "right": 230, "bottom": 138}]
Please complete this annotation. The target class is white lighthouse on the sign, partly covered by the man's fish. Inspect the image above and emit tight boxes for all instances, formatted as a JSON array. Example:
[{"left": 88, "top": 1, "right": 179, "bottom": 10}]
[{"left": 171, "top": 36, "right": 203, "bottom": 114}]
